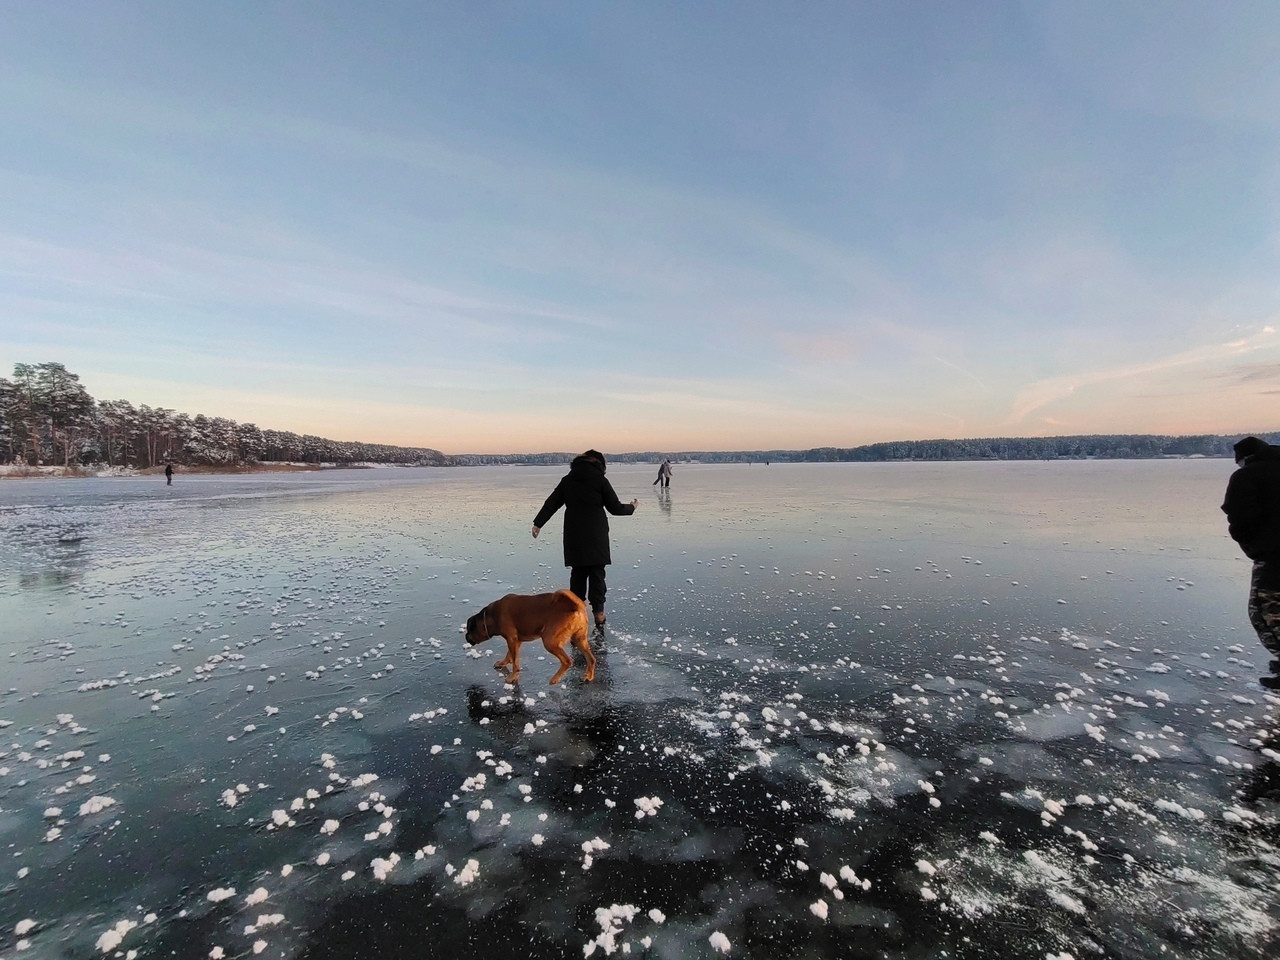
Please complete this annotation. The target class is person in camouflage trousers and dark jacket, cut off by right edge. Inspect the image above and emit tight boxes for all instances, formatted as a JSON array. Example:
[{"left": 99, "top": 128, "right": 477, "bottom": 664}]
[{"left": 1222, "top": 436, "right": 1280, "bottom": 690}]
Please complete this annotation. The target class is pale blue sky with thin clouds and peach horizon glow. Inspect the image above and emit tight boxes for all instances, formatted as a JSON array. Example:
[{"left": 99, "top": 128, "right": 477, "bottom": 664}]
[{"left": 0, "top": 0, "right": 1280, "bottom": 454}]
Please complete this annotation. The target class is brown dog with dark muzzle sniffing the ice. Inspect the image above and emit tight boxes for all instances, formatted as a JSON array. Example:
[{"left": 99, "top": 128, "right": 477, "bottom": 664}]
[{"left": 467, "top": 590, "right": 595, "bottom": 684}]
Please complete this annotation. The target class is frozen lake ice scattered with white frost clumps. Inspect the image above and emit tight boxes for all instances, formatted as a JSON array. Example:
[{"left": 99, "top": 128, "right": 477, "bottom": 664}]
[{"left": 0, "top": 461, "right": 1280, "bottom": 960}]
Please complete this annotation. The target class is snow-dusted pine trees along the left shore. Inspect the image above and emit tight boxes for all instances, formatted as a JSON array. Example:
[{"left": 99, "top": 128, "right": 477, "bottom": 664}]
[{"left": 0, "top": 364, "right": 449, "bottom": 468}]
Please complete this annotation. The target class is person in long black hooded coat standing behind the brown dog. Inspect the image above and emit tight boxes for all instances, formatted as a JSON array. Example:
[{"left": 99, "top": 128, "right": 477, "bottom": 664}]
[{"left": 534, "top": 451, "right": 639, "bottom": 625}]
